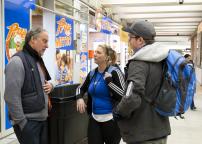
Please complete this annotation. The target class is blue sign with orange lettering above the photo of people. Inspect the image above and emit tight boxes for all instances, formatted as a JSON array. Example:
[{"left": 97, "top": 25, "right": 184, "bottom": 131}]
[{"left": 55, "top": 15, "right": 74, "bottom": 50}]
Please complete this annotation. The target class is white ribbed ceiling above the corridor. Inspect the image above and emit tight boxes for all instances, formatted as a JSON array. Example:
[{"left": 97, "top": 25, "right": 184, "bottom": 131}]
[{"left": 100, "top": 0, "right": 202, "bottom": 41}]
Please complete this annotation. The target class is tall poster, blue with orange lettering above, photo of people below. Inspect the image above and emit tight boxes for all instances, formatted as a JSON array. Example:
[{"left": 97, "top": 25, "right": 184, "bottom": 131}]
[{"left": 55, "top": 15, "right": 74, "bottom": 85}]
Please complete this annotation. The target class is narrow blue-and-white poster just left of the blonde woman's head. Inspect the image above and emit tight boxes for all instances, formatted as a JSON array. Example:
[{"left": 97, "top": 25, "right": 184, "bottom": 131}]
[{"left": 80, "top": 52, "right": 88, "bottom": 82}]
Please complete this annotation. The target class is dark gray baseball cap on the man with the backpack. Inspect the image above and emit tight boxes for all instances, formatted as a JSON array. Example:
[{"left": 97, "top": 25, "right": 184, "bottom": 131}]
[{"left": 122, "top": 21, "right": 156, "bottom": 40}]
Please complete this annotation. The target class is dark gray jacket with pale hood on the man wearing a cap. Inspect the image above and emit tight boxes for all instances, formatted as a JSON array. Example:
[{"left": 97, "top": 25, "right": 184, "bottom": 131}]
[{"left": 116, "top": 43, "right": 171, "bottom": 143}]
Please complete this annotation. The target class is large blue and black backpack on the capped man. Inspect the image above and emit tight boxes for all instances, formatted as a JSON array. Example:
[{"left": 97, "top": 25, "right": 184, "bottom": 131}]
[{"left": 153, "top": 50, "right": 196, "bottom": 116}]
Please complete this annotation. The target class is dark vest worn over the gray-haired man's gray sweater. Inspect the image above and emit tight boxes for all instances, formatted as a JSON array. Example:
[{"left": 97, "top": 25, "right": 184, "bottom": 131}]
[{"left": 15, "top": 51, "right": 45, "bottom": 114}]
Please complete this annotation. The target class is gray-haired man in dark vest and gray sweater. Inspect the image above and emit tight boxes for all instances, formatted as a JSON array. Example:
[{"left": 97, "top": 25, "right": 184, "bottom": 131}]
[{"left": 4, "top": 28, "right": 53, "bottom": 144}]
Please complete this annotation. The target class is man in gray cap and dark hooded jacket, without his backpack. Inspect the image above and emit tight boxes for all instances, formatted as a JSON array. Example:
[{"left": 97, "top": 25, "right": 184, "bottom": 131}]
[{"left": 113, "top": 21, "right": 171, "bottom": 144}]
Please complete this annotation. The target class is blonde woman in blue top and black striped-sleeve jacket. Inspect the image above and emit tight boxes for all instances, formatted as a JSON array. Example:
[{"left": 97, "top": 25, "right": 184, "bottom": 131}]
[{"left": 77, "top": 45, "right": 125, "bottom": 144}]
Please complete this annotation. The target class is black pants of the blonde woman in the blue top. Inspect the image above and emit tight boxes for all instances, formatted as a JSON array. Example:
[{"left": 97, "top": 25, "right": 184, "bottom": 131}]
[{"left": 88, "top": 117, "right": 121, "bottom": 144}]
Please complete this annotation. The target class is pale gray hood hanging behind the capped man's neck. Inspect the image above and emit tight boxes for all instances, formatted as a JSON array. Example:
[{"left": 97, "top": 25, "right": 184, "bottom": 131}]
[{"left": 129, "top": 43, "right": 169, "bottom": 62}]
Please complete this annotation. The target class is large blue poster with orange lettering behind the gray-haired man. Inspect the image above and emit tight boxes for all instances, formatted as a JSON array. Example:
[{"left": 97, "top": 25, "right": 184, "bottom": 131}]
[{"left": 4, "top": 0, "right": 32, "bottom": 129}]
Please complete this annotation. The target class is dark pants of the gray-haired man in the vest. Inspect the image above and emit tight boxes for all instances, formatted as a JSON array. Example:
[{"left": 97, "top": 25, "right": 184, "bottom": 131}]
[{"left": 13, "top": 120, "right": 48, "bottom": 144}]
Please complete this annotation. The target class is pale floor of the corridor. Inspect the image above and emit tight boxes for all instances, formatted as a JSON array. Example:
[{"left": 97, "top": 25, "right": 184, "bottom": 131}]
[{"left": 0, "top": 86, "right": 202, "bottom": 144}]
